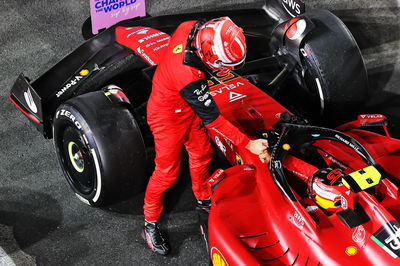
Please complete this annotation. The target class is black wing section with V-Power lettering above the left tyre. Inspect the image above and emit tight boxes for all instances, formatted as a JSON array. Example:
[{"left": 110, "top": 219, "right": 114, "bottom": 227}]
[{"left": 9, "top": 24, "right": 132, "bottom": 137}]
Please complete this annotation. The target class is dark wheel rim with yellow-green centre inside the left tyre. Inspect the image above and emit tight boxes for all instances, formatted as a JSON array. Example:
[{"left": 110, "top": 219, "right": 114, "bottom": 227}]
[{"left": 58, "top": 126, "right": 96, "bottom": 196}]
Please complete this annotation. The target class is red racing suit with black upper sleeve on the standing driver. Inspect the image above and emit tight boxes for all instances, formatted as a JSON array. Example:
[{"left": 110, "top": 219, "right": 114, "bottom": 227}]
[{"left": 144, "top": 21, "right": 249, "bottom": 221}]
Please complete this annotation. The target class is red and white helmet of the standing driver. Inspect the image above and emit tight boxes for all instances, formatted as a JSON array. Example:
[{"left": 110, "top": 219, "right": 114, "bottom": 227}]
[{"left": 194, "top": 17, "right": 246, "bottom": 71}]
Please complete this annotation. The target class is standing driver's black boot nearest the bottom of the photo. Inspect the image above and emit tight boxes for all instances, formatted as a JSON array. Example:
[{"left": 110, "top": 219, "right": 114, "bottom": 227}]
[{"left": 142, "top": 220, "right": 170, "bottom": 256}]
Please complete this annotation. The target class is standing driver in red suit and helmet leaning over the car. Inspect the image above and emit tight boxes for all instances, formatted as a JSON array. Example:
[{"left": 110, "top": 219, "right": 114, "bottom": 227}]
[{"left": 142, "top": 17, "right": 269, "bottom": 255}]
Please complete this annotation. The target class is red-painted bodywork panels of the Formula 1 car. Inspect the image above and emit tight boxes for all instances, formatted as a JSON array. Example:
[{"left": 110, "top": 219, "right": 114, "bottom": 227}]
[{"left": 116, "top": 27, "right": 400, "bottom": 265}]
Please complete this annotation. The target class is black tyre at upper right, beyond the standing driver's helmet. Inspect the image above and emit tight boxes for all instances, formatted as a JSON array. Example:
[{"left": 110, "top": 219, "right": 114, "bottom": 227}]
[{"left": 302, "top": 9, "right": 368, "bottom": 118}]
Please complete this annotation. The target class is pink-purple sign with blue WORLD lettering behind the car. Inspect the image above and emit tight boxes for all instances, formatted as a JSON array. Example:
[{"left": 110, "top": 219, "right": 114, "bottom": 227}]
[{"left": 90, "top": 0, "right": 146, "bottom": 34}]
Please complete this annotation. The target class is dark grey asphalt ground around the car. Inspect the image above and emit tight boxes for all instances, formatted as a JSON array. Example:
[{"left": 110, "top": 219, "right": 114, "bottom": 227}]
[{"left": 0, "top": 0, "right": 400, "bottom": 265}]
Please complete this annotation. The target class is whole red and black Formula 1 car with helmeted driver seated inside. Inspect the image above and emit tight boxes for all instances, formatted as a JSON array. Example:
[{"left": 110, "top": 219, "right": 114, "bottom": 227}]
[{"left": 10, "top": 0, "right": 400, "bottom": 265}]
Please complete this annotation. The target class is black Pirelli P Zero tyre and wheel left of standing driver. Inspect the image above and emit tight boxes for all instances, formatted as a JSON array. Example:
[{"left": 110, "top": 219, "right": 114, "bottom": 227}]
[{"left": 53, "top": 91, "right": 147, "bottom": 206}]
